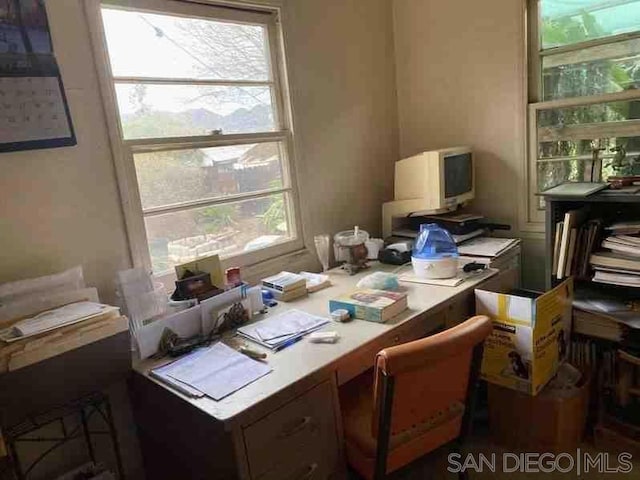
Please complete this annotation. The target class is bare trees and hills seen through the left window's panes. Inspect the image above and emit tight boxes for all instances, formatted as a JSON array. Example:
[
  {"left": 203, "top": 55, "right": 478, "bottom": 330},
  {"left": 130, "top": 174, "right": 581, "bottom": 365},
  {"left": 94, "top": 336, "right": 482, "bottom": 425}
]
[{"left": 103, "top": 8, "right": 290, "bottom": 272}]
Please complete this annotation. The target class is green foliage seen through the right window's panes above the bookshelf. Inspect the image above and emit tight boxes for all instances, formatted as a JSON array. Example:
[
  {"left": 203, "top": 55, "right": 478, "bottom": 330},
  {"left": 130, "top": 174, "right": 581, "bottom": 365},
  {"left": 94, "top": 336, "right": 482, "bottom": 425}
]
[{"left": 538, "top": 2, "right": 640, "bottom": 191}]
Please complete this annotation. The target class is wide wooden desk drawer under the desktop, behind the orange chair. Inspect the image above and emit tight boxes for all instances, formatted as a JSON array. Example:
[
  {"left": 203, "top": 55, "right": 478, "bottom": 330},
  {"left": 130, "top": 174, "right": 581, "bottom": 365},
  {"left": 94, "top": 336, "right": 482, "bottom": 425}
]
[{"left": 338, "top": 309, "right": 446, "bottom": 385}]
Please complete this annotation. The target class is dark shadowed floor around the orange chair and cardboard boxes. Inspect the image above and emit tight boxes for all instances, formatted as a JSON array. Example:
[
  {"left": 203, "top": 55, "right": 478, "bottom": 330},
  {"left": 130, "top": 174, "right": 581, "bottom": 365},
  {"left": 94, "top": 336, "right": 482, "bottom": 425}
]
[{"left": 349, "top": 430, "right": 640, "bottom": 480}]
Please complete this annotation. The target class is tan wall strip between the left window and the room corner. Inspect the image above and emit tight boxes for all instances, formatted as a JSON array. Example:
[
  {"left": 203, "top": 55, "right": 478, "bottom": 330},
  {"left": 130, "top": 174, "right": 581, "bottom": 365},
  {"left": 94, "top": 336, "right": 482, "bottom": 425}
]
[{"left": 285, "top": 0, "right": 398, "bottom": 244}]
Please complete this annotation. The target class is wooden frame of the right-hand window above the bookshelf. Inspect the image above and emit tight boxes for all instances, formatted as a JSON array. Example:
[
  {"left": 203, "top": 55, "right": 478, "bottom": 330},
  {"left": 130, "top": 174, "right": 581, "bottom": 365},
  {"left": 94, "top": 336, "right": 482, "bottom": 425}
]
[{"left": 521, "top": 0, "right": 640, "bottom": 232}]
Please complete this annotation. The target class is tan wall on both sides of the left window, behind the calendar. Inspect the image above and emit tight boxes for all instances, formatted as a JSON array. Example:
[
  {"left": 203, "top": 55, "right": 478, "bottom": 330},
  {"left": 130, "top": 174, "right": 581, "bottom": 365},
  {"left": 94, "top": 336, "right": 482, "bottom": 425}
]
[{"left": 0, "top": 0, "right": 398, "bottom": 478}]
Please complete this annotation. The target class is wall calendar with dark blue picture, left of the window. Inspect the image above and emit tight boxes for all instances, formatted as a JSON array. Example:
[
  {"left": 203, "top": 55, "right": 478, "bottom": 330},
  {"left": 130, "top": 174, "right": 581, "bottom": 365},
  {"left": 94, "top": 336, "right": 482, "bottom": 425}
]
[{"left": 0, "top": 0, "right": 76, "bottom": 152}]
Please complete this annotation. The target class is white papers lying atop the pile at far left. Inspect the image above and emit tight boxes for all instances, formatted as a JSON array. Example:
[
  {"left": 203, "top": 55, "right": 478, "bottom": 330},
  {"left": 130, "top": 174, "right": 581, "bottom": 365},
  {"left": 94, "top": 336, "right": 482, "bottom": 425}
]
[{"left": 0, "top": 302, "right": 118, "bottom": 342}]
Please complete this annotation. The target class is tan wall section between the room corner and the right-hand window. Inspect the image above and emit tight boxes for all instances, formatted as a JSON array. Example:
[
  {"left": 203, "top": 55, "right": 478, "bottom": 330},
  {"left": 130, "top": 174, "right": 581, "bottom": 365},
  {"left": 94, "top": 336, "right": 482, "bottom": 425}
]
[{"left": 393, "top": 0, "right": 544, "bottom": 288}]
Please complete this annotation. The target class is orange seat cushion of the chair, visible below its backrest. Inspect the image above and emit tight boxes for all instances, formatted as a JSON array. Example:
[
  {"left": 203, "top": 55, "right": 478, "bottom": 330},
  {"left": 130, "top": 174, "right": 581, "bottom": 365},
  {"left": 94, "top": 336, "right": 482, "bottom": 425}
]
[{"left": 340, "top": 372, "right": 464, "bottom": 478}]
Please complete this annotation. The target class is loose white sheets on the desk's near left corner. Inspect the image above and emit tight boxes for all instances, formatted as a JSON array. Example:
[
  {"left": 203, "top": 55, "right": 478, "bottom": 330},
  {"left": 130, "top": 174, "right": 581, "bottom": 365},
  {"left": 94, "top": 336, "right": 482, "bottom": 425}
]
[{"left": 150, "top": 343, "right": 272, "bottom": 400}]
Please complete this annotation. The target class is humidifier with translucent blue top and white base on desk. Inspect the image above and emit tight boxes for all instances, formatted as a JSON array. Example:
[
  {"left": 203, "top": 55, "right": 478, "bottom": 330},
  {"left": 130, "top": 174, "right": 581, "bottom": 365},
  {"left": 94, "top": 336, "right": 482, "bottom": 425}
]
[{"left": 411, "top": 223, "right": 458, "bottom": 279}]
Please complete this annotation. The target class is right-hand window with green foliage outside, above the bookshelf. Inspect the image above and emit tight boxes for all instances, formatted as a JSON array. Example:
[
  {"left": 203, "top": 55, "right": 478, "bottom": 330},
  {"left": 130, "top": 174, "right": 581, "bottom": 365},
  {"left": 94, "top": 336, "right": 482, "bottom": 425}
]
[{"left": 527, "top": 0, "right": 640, "bottom": 222}]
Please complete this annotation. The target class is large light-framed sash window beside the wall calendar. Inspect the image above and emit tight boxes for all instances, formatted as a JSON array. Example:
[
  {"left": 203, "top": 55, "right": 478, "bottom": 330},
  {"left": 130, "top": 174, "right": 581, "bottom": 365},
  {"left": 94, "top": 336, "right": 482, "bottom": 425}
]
[{"left": 89, "top": 0, "right": 302, "bottom": 275}]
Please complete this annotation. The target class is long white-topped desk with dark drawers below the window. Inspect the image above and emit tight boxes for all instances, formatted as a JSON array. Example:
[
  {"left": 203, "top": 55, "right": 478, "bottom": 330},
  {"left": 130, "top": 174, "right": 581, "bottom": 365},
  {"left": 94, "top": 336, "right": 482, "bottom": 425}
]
[{"left": 130, "top": 265, "right": 520, "bottom": 480}]
